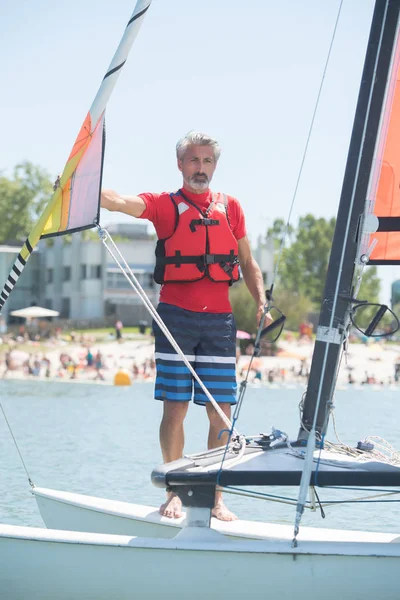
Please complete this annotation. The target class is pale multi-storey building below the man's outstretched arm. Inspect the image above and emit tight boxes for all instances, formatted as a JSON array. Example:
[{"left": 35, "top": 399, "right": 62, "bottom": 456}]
[{"left": 41, "top": 223, "right": 159, "bottom": 326}]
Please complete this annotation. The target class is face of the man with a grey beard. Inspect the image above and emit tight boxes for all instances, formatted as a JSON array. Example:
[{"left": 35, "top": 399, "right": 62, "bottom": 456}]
[{"left": 178, "top": 146, "right": 217, "bottom": 193}]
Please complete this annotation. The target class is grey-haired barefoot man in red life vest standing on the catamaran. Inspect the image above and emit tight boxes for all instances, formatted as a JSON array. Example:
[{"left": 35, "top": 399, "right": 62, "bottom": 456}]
[{"left": 101, "top": 131, "right": 270, "bottom": 521}]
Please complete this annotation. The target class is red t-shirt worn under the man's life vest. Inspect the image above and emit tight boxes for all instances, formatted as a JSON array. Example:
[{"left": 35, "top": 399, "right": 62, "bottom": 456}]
[{"left": 139, "top": 188, "right": 246, "bottom": 313}]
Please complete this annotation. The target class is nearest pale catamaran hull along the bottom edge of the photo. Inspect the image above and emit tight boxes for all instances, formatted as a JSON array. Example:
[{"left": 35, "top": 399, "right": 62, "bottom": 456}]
[{"left": 0, "top": 525, "right": 400, "bottom": 600}]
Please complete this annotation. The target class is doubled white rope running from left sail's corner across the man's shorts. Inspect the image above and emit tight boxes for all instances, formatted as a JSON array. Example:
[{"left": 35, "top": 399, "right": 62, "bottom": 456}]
[{"left": 98, "top": 226, "right": 242, "bottom": 439}]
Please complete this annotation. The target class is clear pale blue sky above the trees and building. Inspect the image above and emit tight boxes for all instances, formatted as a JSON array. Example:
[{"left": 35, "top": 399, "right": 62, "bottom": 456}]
[{"left": 0, "top": 0, "right": 400, "bottom": 301}]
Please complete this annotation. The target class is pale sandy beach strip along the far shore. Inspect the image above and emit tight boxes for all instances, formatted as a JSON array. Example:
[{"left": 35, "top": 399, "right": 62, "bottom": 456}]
[{"left": 0, "top": 336, "right": 400, "bottom": 386}]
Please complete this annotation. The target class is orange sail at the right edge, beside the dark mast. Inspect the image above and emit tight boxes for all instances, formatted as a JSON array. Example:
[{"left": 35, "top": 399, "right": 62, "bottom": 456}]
[{"left": 368, "top": 22, "right": 400, "bottom": 265}]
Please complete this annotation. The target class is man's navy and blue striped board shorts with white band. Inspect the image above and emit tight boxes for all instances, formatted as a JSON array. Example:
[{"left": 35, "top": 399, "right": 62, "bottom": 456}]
[{"left": 153, "top": 302, "right": 237, "bottom": 406}]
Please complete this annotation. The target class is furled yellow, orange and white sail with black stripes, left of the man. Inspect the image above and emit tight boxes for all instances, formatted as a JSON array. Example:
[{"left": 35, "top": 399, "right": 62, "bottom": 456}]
[{"left": 0, "top": 0, "right": 151, "bottom": 311}]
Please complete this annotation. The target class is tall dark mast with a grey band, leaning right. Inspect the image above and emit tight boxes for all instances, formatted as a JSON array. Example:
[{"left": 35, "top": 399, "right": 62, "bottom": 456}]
[{"left": 299, "top": 0, "right": 400, "bottom": 440}]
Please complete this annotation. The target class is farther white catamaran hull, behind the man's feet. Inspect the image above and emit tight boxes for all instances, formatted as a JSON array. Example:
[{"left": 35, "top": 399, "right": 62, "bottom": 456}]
[{"left": 33, "top": 487, "right": 400, "bottom": 544}]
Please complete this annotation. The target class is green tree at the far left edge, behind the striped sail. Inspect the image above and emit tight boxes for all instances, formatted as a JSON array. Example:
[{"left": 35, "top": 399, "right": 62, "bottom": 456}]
[{"left": 0, "top": 162, "right": 53, "bottom": 244}]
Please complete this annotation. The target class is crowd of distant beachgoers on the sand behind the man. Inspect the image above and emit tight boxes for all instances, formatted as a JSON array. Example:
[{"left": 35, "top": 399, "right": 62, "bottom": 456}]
[{"left": 0, "top": 320, "right": 400, "bottom": 386}]
